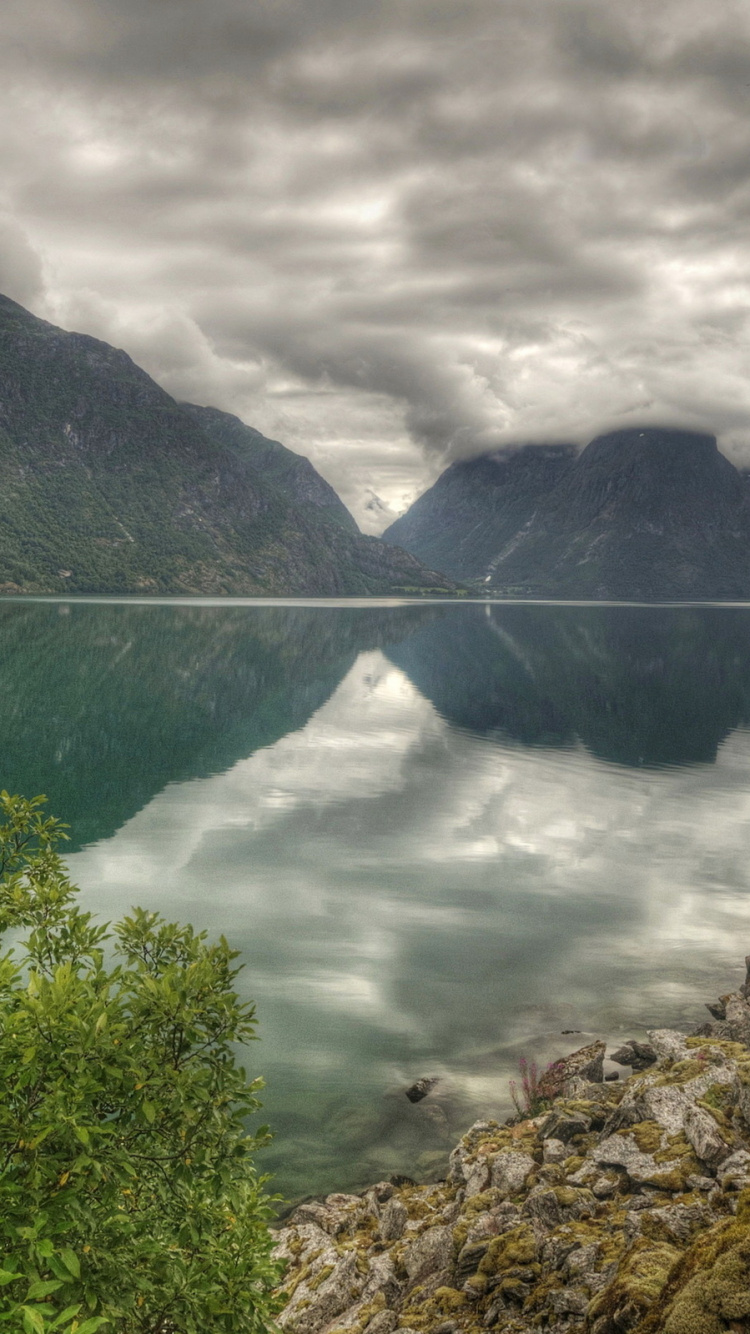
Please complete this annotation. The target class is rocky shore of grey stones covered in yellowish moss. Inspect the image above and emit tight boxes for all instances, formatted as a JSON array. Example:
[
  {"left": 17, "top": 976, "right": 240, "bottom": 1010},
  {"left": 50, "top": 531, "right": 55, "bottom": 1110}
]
[{"left": 268, "top": 960, "right": 750, "bottom": 1334}]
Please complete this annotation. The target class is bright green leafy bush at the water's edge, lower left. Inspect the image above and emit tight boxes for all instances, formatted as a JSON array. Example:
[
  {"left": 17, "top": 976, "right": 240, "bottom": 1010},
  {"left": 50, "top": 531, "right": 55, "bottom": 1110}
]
[{"left": 0, "top": 792, "right": 279, "bottom": 1334}]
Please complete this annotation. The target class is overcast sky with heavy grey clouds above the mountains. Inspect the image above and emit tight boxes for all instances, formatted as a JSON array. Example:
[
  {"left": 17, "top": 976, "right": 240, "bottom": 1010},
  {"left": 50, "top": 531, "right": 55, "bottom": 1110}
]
[{"left": 0, "top": 0, "right": 750, "bottom": 532}]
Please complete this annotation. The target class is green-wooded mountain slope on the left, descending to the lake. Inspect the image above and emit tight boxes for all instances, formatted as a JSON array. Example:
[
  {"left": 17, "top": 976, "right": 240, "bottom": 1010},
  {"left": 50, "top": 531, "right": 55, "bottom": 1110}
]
[{"left": 0, "top": 297, "right": 452, "bottom": 596}]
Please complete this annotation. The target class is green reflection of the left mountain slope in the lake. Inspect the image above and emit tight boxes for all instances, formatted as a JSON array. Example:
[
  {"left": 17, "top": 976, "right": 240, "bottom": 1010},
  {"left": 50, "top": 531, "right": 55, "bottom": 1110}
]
[{"left": 0, "top": 600, "right": 432, "bottom": 847}]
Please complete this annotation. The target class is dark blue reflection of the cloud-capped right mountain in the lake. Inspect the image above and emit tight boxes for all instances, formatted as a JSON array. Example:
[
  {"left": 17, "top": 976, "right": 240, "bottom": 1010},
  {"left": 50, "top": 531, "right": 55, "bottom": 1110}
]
[{"left": 390, "top": 604, "right": 750, "bottom": 766}]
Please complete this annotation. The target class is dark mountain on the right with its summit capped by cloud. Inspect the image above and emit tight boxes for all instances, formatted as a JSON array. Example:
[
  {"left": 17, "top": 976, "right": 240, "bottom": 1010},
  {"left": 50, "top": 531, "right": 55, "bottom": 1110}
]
[{"left": 384, "top": 427, "right": 750, "bottom": 600}]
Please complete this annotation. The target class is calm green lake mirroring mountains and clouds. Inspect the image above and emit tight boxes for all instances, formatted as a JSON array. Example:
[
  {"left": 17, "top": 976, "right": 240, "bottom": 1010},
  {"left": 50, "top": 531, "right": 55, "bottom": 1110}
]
[{"left": 0, "top": 600, "right": 750, "bottom": 1197}]
